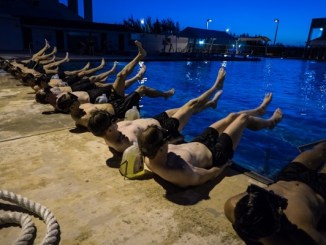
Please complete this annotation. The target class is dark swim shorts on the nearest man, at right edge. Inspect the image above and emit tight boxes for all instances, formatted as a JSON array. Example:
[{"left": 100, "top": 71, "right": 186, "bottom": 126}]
[{"left": 276, "top": 162, "right": 326, "bottom": 200}]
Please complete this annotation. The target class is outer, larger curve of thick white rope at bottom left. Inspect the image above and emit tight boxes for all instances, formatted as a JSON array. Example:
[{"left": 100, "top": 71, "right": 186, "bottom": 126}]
[{"left": 0, "top": 190, "right": 59, "bottom": 245}]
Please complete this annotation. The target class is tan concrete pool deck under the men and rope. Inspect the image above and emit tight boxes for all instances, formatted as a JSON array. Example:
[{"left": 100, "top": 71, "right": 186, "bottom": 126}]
[{"left": 0, "top": 58, "right": 262, "bottom": 245}]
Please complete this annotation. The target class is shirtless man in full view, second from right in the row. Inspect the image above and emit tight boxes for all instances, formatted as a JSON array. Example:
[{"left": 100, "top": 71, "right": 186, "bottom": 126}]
[{"left": 137, "top": 94, "right": 282, "bottom": 187}]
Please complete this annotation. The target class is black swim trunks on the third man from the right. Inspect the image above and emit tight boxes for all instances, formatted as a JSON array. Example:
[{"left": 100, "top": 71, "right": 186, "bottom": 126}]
[{"left": 153, "top": 112, "right": 184, "bottom": 144}]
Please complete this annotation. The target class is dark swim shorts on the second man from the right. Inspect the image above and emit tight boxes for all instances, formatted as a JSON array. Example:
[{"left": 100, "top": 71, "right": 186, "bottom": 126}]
[{"left": 191, "top": 127, "right": 233, "bottom": 167}]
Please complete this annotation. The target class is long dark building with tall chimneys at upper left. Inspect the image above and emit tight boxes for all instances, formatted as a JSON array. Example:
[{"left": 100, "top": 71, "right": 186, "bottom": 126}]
[{"left": 0, "top": 0, "right": 135, "bottom": 54}]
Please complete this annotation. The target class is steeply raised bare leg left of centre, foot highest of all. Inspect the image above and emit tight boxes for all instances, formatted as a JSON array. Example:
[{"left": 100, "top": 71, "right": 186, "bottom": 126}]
[{"left": 112, "top": 41, "right": 147, "bottom": 96}]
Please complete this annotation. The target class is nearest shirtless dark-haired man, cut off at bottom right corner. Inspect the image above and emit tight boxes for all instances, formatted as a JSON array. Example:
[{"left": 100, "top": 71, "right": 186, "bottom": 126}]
[{"left": 224, "top": 142, "right": 326, "bottom": 245}]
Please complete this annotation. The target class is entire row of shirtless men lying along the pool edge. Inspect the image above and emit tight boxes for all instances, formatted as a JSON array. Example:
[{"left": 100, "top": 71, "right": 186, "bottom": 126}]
[{"left": 1, "top": 41, "right": 326, "bottom": 244}]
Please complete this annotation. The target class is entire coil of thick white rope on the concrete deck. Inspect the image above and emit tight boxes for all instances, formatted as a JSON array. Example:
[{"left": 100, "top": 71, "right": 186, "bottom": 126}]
[{"left": 0, "top": 190, "right": 59, "bottom": 245}]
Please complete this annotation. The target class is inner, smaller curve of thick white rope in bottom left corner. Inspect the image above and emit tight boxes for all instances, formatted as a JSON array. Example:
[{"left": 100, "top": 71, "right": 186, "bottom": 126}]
[{"left": 0, "top": 212, "right": 35, "bottom": 245}]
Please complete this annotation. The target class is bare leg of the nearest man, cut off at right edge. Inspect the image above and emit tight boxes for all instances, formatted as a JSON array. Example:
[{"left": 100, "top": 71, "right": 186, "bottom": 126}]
[{"left": 293, "top": 142, "right": 326, "bottom": 173}]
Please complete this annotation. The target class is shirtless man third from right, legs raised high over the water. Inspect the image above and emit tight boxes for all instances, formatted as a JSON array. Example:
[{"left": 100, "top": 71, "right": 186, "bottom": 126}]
[{"left": 88, "top": 68, "right": 226, "bottom": 153}]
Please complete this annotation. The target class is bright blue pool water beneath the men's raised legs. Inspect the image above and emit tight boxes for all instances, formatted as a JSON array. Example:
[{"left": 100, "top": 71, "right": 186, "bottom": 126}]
[{"left": 65, "top": 58, "right": 326, "bottom": 179}]
